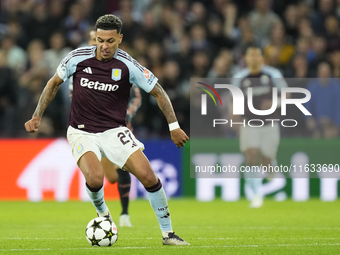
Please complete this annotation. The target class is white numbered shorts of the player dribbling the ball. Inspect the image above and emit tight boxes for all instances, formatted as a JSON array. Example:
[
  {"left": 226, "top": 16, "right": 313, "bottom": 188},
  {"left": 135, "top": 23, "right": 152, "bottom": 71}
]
[{"left": 67, "top": 126, "right": 144, "bottom": 168}]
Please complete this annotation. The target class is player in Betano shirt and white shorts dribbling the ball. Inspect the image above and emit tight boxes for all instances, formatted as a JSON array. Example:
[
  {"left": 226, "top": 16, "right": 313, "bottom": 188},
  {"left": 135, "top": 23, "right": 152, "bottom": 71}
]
[{"left": 25, "top": 14, "right": 189, "bottom": 245}]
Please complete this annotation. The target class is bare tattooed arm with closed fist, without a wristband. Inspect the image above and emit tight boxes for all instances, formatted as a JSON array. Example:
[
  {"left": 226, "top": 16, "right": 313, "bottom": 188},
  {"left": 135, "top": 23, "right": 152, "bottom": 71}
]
[{"left": 25, "top": 74, "right": 63, "bottom": 133}]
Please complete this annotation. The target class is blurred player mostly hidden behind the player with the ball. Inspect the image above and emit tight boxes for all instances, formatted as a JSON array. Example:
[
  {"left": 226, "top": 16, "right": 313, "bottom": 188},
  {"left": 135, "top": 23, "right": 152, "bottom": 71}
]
[{"left": 69, "top": 30, "right": 142, "bottom": 227}]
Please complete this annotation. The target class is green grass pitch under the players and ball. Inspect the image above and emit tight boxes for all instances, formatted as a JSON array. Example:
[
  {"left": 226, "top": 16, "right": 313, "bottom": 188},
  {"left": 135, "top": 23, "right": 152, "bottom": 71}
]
[{"left": 0, "top": 199, "right": 340, "bottom": 255}]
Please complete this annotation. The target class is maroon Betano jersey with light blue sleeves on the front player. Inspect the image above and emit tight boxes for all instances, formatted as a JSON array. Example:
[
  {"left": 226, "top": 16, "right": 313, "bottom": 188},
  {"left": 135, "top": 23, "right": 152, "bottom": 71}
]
[{"left": 57, "top": 45, "right": 158, "bottom": 133}]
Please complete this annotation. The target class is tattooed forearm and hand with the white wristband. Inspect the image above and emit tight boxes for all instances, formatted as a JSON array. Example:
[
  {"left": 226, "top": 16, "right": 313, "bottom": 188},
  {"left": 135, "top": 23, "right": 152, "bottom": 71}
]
[{"left": 150, "top": 83, "right": 189, "bottom": 148}]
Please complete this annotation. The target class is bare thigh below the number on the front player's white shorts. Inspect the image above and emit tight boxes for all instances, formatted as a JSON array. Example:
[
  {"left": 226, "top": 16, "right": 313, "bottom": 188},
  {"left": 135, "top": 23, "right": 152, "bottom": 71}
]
[{"left": 123, "top": 150, "right": 158, "bottom": 188}]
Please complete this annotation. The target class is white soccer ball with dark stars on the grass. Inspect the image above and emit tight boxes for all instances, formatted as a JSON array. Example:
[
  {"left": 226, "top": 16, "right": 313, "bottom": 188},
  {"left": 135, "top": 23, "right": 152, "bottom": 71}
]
[{"left": 85, "top": 217, "right": 118, "bottom": 246}]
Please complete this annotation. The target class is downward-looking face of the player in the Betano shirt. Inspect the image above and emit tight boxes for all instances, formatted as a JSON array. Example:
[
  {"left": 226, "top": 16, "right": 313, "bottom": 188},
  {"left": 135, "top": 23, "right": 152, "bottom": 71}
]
[{"left": 96, "top": 29, "right": 123, "bottom": 61}]
